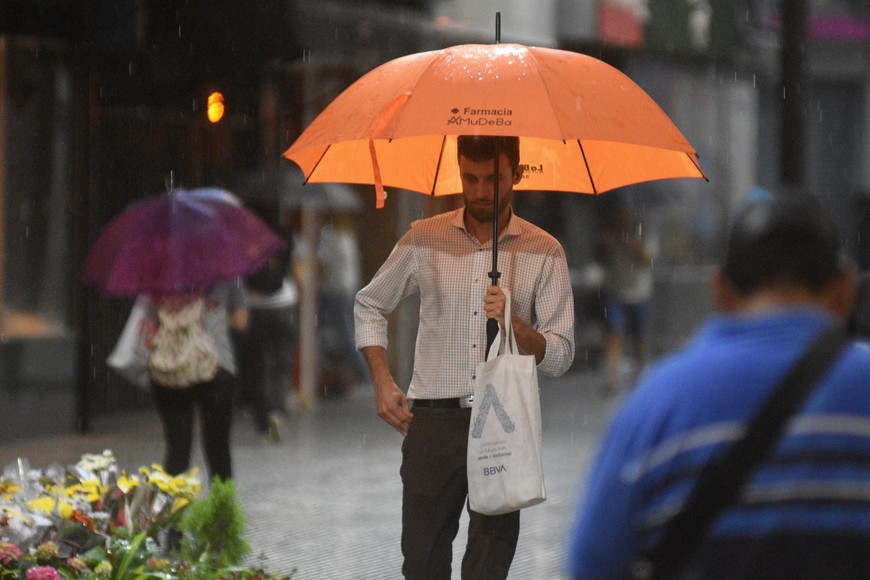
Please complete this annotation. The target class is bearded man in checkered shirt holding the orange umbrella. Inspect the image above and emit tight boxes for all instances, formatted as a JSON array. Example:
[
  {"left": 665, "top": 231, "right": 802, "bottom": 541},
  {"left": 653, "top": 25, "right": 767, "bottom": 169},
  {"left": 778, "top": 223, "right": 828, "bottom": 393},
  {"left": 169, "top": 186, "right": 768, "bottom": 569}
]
[{"left": 354, "top": 136, "right": 574, "bottom": 579}]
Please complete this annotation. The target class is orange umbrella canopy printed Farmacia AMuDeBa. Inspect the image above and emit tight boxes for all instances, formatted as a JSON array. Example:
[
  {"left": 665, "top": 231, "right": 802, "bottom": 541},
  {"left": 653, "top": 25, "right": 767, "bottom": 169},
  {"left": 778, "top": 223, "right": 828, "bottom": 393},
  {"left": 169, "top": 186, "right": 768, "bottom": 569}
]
[{"left": 284, "top": 44, "right": 704, "bottom": 207}]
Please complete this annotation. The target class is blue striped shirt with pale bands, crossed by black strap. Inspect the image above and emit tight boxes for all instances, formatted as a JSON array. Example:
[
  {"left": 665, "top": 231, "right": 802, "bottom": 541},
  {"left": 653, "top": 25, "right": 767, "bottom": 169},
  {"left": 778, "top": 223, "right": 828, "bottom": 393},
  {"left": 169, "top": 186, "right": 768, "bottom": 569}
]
[{"left": 568, "top": 308, "right": 870, "bottom": 579}]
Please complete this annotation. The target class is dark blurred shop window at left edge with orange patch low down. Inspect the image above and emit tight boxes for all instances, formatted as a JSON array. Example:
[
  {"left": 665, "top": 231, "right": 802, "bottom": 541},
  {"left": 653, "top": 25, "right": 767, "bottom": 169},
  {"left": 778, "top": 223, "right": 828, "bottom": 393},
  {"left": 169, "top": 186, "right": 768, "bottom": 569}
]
[{"left": 0, "top": 37, "right": 81, "bottom": 439}]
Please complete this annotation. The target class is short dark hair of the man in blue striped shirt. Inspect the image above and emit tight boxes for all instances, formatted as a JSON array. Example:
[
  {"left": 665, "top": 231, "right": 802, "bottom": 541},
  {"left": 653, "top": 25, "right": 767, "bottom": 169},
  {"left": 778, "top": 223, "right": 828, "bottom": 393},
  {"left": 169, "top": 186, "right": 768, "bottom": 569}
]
[{"left": 722, "top": 195, "right": 842, "bottom": 296}]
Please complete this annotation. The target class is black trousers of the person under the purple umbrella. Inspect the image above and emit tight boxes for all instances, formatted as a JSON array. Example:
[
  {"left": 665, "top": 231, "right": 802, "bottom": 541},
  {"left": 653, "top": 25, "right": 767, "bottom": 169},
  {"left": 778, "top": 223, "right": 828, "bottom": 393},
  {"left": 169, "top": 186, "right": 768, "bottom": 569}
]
[{"left": 152, "top": 368, "right": 235, "bottom": 479}]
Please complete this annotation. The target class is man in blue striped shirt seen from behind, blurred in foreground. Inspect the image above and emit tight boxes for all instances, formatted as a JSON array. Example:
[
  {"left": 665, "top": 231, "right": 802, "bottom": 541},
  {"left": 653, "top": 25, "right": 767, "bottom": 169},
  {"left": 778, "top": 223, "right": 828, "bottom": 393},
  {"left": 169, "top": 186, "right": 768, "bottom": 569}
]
[{"left": 568, "top": 196, "right": 870, "bottom": 580}]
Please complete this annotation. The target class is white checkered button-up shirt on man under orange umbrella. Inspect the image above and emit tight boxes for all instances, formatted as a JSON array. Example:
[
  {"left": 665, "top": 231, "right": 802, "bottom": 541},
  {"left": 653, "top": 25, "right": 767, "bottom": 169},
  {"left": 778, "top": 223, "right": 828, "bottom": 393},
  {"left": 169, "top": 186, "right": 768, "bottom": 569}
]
[{"left": 354, "top": 209, "right": 574, "bottom": 399}]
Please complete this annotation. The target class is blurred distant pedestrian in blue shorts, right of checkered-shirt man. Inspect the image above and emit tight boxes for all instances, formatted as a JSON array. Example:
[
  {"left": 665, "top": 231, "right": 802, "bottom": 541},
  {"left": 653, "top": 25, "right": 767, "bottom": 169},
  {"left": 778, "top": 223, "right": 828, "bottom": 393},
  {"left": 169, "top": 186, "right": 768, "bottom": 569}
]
[{"left": 599, "top": 202, "right": 655, "bottom": 393}]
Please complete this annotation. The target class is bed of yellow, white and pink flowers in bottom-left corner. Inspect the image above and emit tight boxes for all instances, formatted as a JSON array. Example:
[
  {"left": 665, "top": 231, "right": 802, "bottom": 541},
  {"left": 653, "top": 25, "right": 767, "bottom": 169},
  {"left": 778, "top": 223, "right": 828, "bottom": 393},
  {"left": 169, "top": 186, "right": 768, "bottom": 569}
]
[{"left": 0, "top": 450, "right": 289, "bottom": 580}]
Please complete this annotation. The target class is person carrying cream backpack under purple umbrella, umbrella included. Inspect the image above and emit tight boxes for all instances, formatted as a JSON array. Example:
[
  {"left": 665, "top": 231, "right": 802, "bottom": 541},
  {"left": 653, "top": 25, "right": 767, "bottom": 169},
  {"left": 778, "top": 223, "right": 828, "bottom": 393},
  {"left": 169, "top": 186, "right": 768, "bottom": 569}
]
[{"left": 82, "top": 188, "right": 276, "bottom": 479}]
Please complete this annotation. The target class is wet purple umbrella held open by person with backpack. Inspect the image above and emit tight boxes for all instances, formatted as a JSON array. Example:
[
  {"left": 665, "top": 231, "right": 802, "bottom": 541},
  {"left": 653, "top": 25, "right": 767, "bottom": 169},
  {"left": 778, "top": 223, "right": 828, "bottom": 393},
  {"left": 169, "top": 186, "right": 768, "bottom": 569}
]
[{"left": 83, "top": 188, "right": 283, "bottom": 296}]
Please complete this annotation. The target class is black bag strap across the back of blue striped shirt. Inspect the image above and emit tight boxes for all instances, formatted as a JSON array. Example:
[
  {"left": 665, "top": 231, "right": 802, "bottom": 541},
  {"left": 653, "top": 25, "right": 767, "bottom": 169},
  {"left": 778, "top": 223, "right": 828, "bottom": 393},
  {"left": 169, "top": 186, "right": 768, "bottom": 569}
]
[{"left": 633, "top": 325, "right": 848, "bottom": 579}]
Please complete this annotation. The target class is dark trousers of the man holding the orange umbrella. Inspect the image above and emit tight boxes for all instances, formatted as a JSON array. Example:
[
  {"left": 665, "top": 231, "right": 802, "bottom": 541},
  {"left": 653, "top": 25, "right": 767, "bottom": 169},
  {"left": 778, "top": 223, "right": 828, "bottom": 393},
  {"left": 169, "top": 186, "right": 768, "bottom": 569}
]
[{"left": 401, "top": 407, "right": 520, "bottom": 580}]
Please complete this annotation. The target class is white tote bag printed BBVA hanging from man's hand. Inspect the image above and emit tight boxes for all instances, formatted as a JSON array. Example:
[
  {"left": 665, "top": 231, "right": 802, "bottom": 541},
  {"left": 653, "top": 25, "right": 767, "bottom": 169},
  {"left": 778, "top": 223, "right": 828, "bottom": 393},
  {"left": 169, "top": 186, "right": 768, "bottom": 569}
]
[{"left": 467, "top": 290, "right": 547, "bottom": 515}]
